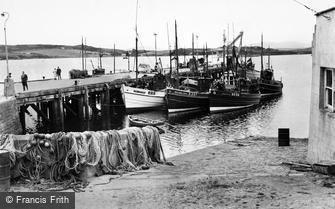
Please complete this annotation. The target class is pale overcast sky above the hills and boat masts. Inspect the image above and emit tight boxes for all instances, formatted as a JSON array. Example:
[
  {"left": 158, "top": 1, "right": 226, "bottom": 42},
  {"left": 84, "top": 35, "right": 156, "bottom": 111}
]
[{"left": 0, "top": 0, "right": 335, "bottom": 49}]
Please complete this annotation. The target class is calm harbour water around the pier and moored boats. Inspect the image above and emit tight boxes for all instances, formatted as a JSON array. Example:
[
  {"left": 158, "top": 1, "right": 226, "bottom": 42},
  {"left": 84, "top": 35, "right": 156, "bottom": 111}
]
[{"left": 0, "top": 55, "right": 312, "bottom": 156}]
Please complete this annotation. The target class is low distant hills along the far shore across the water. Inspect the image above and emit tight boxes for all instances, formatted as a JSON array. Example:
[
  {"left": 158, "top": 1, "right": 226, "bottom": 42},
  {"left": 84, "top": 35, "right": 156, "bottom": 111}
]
[{"left": 0, "top": 44, "right": 311, "bottom": 60}]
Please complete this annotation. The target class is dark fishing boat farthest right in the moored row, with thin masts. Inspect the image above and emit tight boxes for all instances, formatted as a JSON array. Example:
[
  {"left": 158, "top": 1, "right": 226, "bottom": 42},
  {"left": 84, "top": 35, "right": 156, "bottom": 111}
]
[{"left": 259, "top": 35, "right": 283, "bottom": 100}]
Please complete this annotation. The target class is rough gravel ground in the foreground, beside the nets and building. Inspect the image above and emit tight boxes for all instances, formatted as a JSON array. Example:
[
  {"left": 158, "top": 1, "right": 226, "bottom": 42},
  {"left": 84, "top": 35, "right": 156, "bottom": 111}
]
[{"left": 13, "top": 137, "right": 335, "bottom": 209}]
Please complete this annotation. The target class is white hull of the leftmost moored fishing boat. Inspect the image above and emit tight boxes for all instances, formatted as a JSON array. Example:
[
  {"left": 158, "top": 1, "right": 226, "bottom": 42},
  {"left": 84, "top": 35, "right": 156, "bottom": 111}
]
[{"left": 121, "top": 85, "right": 165, "bottom": 111}]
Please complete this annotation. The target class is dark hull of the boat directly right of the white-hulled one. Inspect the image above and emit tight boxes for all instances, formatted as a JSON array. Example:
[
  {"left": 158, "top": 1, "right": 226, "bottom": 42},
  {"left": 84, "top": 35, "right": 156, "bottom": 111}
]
[{"left": 166, "top": 89, "right": 209, "bottom": 113}]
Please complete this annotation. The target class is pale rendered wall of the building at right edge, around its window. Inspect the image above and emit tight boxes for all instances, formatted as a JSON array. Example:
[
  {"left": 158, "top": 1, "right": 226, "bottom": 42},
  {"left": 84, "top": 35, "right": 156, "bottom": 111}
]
[{"left": 308, "top": 11, "right": 335, "bottom": 163}]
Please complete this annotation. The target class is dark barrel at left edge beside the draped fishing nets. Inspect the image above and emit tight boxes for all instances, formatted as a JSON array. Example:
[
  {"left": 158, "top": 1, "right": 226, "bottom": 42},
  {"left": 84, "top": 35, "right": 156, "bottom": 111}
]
[{"left": 0, "top": 150, "right": 10, "bottom": 192}]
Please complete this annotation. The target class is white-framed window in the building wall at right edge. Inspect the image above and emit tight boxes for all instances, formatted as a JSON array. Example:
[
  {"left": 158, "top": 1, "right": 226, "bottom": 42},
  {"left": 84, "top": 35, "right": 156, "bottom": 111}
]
[{"left": 324, "top": 68, "right": 335, "bottom": 111}]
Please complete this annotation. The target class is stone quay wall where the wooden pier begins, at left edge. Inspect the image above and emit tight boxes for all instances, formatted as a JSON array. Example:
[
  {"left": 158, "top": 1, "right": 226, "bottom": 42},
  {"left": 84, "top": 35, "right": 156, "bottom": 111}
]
[{"left": 0, "top": 97, "right": 22, "bottom": 134}]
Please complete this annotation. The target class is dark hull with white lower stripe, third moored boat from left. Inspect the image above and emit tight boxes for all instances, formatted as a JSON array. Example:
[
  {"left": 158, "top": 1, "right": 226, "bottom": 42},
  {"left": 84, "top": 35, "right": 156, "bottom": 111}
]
[{"left": 209, "top": 93, "right": 261, "bottom": 113}]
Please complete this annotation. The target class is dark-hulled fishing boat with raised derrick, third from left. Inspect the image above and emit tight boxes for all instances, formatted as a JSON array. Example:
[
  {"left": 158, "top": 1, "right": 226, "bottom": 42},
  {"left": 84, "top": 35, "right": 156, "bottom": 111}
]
[{"left": 208, "top": 32, "right": 261, "bottom": 113}]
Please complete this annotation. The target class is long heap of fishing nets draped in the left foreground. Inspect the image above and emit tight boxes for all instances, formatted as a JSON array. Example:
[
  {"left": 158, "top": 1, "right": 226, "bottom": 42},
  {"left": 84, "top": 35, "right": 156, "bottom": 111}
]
[{"left": 0, "top": 126, "right": 165, "bottom": 189}]
